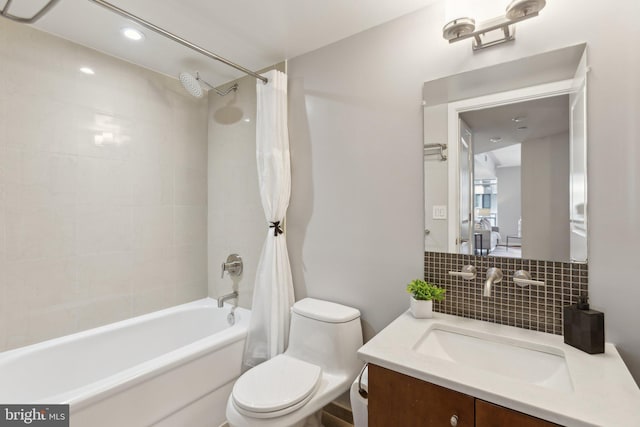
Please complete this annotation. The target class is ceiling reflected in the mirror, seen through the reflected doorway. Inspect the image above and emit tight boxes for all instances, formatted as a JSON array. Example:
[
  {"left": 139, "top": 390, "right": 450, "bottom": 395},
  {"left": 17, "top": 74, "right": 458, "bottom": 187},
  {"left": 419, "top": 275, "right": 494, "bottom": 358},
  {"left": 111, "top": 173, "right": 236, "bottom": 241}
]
[{"left": 460, "top": 95, "right": 569, "bottom": 167}]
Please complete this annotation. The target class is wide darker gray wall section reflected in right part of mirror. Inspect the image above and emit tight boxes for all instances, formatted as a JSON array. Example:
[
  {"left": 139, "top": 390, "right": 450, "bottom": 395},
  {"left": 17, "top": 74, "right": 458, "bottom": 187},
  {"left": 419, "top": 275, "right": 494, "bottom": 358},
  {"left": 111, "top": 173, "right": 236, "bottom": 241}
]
[{"left": 521, "top": 132, "right": 570, "bottom": 262}]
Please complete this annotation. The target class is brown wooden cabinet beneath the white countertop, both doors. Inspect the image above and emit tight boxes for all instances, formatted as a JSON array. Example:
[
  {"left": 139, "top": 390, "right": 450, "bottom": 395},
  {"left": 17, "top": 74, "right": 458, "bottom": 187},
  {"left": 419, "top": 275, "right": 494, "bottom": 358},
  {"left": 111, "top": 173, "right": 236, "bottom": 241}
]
[{"left": 368, "top": 364, "right": 557, "bottom": 427}]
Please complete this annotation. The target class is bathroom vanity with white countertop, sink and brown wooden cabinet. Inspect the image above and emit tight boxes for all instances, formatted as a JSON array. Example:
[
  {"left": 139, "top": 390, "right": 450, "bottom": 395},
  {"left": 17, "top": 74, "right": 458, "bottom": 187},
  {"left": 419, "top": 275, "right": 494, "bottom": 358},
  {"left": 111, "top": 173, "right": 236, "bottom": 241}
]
[{"left": 358, "top": 312, "right": 640, "bottom": 427}]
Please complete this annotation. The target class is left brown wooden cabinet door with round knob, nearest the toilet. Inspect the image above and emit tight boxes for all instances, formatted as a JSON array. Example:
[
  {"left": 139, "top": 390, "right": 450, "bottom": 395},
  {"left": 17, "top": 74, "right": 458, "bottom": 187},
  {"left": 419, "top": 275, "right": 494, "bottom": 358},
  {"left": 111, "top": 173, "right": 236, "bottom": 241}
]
[{"left": 369, "top": 365, "right": 474, "bottom": 427}]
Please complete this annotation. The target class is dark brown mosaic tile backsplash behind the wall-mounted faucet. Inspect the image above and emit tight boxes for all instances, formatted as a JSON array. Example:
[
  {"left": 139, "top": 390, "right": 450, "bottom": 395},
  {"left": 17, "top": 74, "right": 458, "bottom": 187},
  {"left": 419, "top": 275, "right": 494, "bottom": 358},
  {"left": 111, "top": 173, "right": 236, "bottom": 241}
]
[{"left": 424, "top": 252, "right": 588, "bottom": 334}]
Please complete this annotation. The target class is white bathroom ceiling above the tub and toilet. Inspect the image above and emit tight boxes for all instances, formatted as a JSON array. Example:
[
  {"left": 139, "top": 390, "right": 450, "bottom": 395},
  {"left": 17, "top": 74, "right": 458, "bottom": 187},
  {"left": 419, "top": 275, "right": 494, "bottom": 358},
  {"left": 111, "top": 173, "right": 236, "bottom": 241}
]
[{"left": 8, "top": 0, "right": 437, "bottom": 86}]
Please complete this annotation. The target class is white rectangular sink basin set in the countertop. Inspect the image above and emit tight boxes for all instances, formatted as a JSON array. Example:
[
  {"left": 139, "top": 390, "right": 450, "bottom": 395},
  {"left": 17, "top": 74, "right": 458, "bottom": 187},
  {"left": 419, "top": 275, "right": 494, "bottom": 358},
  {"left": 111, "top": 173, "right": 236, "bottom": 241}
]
[{"left": 413, "top": 324, "right": 573, "bottom": 391}]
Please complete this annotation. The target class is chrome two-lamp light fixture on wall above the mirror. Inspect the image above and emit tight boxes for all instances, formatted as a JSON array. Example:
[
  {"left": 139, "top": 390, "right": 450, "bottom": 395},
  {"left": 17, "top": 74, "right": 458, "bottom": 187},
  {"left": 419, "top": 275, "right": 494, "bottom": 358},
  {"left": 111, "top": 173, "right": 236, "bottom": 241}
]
[{"left": 442, "top": 0, "right": 546, "bottom": 51}]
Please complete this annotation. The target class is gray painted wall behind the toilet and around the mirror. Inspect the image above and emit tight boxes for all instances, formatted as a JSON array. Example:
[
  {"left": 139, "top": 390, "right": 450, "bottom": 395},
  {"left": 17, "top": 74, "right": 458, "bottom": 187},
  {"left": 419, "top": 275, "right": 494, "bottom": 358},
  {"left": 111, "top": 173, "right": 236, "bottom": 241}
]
[{"left": 288, "top": 0, "right": 640, "bottom": 378}]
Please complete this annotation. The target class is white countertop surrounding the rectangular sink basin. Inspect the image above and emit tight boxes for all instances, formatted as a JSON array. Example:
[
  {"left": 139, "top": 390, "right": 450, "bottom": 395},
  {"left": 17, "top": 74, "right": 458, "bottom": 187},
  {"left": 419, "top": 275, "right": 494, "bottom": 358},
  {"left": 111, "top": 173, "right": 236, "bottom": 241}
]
[{"left": 358, "top": 312, "right": 640, "bottom": 427}]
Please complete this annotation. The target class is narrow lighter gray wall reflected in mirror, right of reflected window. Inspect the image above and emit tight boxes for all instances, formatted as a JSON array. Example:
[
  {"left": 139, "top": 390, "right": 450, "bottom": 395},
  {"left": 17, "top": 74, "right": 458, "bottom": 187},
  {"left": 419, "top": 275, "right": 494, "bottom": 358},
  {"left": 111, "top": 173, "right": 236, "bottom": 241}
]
[{"left": 496, "top": 166, "right": 520, "bottom": 237}]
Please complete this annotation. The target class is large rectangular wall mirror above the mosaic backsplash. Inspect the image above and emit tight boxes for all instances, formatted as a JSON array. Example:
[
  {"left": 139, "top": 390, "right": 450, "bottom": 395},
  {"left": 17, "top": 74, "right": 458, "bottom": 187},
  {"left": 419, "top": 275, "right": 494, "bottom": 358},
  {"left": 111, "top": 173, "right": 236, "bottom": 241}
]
[{"left": 424, "top": 45, "right": 587, "bottom": 262}]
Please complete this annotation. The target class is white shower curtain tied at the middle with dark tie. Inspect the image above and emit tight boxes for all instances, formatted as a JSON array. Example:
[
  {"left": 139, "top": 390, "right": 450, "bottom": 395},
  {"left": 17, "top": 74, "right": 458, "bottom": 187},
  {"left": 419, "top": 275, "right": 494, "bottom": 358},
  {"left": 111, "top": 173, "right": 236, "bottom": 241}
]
[{"left": 243, "top": 70, "right": 294, "bottom": 369}]
